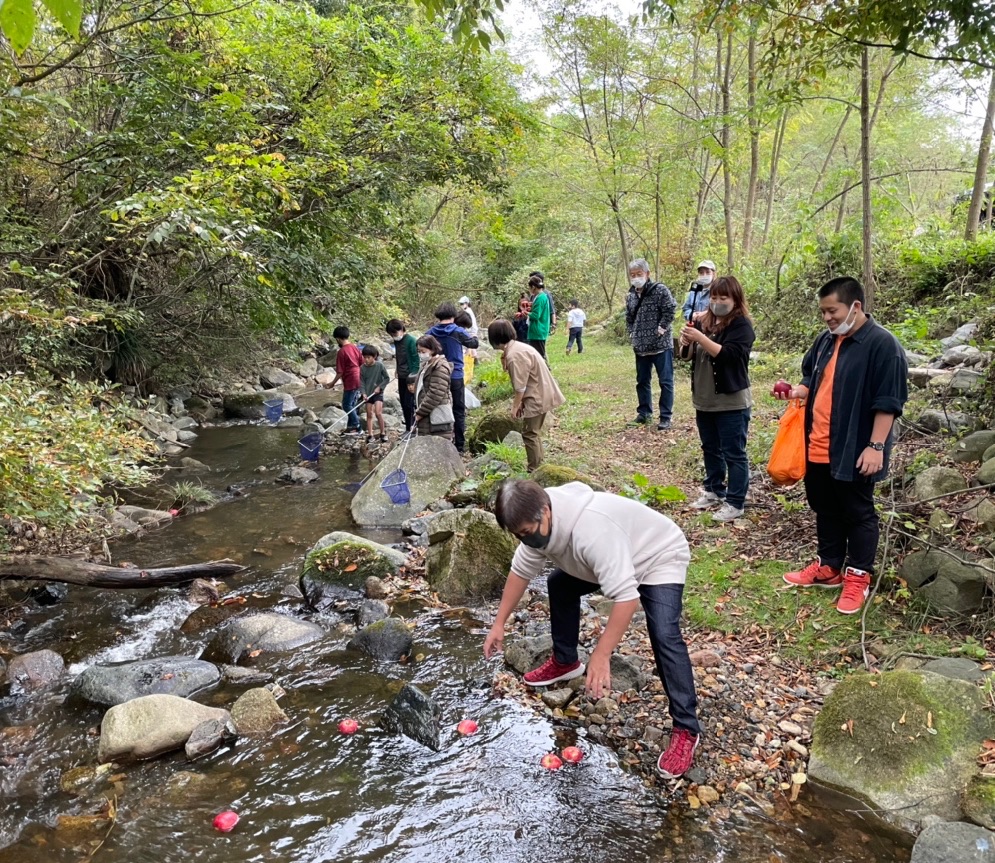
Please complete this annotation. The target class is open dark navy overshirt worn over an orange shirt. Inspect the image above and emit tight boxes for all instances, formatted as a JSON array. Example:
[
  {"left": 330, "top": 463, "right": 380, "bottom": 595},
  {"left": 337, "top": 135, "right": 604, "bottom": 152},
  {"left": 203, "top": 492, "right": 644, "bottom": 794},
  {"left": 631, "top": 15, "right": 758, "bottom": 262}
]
[{"left": 801, "top": 317, "right": 909, "bottom": 482}]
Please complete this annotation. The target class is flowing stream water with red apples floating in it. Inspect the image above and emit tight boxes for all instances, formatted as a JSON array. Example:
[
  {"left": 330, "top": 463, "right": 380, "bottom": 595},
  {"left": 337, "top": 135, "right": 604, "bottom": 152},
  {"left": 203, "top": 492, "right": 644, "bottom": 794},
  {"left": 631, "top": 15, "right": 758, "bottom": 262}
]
[{"left": 0, "top": 426, "right": 909, "bottom": 863}]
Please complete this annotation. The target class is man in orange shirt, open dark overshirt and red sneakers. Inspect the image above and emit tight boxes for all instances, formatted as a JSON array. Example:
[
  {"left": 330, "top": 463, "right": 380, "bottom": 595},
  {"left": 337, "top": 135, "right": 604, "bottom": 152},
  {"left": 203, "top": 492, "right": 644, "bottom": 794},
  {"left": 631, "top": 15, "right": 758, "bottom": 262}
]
[{"left": 774, "top": 277, "right": 909, "bottom": 614}]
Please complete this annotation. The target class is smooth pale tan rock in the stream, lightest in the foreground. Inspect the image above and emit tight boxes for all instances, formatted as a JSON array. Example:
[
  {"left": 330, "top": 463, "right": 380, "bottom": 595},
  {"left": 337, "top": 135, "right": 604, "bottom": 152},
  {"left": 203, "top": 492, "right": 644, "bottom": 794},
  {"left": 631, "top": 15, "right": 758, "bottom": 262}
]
[{"left": 97, "top": 695, "right": 231, "bottom": 763}]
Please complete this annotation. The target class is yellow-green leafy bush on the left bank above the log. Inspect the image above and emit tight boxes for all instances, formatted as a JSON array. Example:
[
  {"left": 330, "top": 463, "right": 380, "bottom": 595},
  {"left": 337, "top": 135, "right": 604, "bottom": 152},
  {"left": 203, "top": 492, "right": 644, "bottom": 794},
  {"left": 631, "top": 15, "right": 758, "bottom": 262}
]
[{"left": 0, "top": 374, "right": 154, "bottom": 527}]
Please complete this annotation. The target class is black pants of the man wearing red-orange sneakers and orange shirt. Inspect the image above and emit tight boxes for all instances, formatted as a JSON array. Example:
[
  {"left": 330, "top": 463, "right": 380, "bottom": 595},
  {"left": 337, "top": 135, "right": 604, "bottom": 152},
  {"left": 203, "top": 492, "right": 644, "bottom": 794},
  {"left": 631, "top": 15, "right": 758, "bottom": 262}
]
[{"left": 805, "top": 462, "right": 879, "bottom": 572}]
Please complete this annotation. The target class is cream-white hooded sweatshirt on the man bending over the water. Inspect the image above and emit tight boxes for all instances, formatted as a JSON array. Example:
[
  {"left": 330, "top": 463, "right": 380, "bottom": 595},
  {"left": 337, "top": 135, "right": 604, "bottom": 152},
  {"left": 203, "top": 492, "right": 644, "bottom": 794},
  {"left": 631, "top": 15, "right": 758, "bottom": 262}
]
[{"left": 511, "top": 482, "right": 691, "bottom": 602}]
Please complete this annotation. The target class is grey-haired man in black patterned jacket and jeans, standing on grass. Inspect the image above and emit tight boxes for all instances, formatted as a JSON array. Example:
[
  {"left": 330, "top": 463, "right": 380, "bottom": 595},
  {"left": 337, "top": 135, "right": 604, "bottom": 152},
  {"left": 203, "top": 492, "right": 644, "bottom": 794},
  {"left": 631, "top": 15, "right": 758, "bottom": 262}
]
[{"left": 625, "top": 258, "right": 677, "bottom": 431}]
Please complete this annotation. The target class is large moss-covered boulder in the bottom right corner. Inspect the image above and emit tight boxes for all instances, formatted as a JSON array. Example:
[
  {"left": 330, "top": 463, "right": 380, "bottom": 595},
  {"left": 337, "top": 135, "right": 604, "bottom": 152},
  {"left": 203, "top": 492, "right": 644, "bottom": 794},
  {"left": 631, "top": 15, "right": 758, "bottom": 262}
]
[{"left": 808, "top": 671, "right": 995, "bottom": 832}]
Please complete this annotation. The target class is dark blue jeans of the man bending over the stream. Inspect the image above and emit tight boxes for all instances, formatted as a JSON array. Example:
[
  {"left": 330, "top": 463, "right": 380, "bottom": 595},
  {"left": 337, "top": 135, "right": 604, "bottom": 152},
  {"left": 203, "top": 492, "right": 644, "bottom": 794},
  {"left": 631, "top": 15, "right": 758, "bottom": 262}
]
[{"left": 548, "top": 569, "right": 701, "bottom": 734}]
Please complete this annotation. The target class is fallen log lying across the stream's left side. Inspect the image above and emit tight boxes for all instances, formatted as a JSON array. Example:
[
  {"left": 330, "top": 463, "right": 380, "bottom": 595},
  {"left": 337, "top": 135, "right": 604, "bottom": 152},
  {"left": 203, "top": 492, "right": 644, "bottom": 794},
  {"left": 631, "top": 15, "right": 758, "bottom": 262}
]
[{"left": 0, "top": 555, "right": 245, "bottom": 588}]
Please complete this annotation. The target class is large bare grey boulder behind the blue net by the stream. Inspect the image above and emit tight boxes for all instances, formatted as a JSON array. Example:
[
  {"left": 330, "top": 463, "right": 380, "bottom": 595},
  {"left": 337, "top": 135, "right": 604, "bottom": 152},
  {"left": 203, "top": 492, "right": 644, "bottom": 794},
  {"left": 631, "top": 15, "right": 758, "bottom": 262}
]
[{"left": 352, "top": 435, "right": 464, "bottom": 527}]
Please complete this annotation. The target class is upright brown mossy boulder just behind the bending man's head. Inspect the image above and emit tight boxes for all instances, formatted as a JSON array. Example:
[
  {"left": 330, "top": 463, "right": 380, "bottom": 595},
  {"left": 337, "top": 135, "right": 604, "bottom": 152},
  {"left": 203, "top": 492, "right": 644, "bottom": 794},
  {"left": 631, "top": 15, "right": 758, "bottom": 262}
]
[{"left": 425, "top": 509, "right": 518, "bottom": 604}]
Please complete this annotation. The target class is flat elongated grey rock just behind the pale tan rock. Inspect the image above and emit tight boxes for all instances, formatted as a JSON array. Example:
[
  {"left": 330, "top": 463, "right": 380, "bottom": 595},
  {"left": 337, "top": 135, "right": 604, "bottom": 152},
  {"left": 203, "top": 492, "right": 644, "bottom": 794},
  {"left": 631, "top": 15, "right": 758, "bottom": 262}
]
[{"left": 71, "top": 656, "right": 221, "bottom": 707}]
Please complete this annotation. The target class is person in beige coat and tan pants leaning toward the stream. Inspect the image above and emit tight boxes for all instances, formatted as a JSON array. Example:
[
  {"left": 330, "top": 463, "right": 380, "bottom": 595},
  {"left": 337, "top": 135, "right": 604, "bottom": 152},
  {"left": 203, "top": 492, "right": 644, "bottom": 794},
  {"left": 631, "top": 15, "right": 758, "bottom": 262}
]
[{"left": 487, "top": 320, "right": 566, "bottom": 472}]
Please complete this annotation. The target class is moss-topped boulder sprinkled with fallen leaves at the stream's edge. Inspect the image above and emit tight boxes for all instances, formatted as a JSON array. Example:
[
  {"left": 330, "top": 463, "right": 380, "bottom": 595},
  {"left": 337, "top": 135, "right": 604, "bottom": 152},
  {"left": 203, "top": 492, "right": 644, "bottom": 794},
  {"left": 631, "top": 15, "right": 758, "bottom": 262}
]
[{"left": 300, "top": 531, "right": 406, "bottom": 611}]
